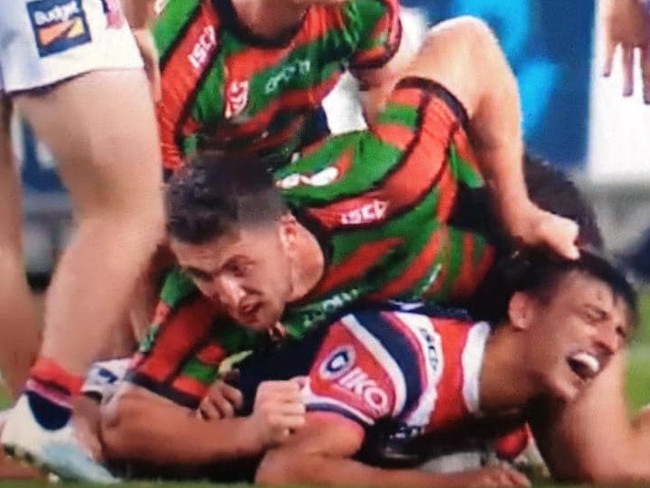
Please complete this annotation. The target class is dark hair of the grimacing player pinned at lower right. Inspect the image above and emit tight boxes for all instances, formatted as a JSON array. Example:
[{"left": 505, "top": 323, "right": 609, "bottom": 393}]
[{"left": 473, "top": 247, "right": 638, "bottom": 327}]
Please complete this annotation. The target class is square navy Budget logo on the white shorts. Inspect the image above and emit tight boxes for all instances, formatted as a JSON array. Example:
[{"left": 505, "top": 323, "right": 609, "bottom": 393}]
[{"left": 27, "top": 0, "right": 90, "bottom": 57}]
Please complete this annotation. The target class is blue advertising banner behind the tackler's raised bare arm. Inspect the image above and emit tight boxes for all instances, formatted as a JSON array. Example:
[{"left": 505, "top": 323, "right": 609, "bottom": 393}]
[{"left": 402, "top": 0, "right": 595, "bottom": 169}]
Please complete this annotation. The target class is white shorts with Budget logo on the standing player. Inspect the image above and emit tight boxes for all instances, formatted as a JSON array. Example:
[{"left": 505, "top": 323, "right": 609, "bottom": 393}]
[{"left": 0, "top": 0, "right": 142, "bottom": 93}]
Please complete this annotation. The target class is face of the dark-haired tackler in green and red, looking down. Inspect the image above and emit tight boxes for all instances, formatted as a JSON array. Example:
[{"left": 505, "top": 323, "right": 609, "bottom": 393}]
[{"left": 171, "top": 223, "right": 291, "bottom": 331}]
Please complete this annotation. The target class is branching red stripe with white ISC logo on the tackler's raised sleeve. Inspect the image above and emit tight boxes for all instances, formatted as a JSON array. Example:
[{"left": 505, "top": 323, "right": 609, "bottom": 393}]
[{"left": 302, "top": 88, "right": 461, "bottom": 231}]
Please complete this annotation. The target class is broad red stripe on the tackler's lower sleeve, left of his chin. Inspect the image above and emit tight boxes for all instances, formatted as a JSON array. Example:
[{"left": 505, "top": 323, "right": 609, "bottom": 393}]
[{"left": 135, "top": 299, "right": 214, "bottom": 383}]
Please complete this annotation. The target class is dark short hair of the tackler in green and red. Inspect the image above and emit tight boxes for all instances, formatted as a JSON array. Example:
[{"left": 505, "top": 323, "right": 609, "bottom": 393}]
[{"left": 165, "top": 152, "right": 286, "bottom": 244}]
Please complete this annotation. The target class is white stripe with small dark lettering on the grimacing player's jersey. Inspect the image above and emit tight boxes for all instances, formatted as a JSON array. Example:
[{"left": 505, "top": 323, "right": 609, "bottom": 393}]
[{"left": 395, "top": 312, "right": 444, "bottom": 426}]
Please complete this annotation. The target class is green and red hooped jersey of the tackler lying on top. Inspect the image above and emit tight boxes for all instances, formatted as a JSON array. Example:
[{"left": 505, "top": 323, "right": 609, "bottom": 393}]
[{"left": 129, "top": 78, "right": 494, "bottom": 407}]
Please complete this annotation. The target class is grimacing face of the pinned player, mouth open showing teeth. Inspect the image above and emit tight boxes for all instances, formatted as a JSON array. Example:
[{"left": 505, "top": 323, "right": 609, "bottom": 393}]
[{"left": 520, "top": 271, "right": 630, "bottom": 401}]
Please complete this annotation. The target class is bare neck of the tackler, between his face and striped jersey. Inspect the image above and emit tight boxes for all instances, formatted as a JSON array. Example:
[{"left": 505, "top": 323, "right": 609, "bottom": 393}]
[{"left": 289, "top": 224, "right": 325, "bottom": 302}]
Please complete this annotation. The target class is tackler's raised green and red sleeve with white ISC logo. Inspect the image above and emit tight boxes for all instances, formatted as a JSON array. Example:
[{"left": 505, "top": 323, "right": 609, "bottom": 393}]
[{"left": 277, "top": 77, "right": 474, "bottom": 231}]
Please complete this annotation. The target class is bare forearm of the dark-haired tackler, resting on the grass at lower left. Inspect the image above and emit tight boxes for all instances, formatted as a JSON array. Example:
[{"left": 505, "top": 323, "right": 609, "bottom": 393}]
[{"left": 102, "top": 392, "right": 262, "bottom": 466}]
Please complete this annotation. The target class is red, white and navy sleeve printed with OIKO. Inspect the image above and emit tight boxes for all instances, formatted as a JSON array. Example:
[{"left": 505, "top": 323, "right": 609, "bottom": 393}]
[{"left": 304, "top": 311, "right": 425, "bottom": 428}]
